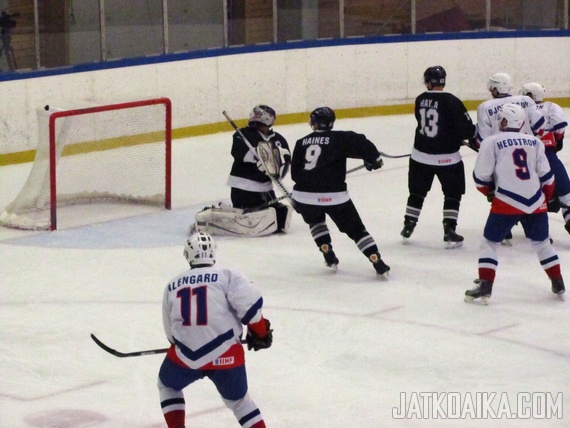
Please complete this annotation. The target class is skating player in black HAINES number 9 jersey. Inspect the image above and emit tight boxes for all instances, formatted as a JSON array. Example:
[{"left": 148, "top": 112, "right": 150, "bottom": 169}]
[{"left": 291, "top": 107, "right": 390, "bottom": 277}]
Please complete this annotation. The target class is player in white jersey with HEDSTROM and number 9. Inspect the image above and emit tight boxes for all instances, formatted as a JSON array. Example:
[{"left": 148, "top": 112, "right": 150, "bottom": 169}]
[{"left": 465, "top": 104, "right": 565, "bottom": 303}]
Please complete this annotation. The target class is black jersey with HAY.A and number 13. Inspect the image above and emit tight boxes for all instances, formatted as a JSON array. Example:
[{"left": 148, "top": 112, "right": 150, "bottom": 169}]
[{"left": 414, "top": 91, "right": 475, "bottom": 155}]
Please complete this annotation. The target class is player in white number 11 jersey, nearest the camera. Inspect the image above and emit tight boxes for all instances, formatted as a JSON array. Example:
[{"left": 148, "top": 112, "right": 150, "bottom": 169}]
[{"left": 158, "top": 232, "right": 273, "bottom": 428}]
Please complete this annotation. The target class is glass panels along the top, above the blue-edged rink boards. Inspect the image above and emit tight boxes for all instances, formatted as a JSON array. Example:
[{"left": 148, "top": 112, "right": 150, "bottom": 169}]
[{"left": 0, "top": 0, "right": 570, "bottom": 72}]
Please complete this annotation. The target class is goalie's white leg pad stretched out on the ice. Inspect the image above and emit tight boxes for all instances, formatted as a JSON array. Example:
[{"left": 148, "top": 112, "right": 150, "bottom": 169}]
[{"left": 190, "top": 203, "right": 293, "bottom": 237}]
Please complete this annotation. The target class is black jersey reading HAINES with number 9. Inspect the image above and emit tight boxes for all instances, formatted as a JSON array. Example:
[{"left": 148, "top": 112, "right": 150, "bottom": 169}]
[{"left": 291, "top": 130, "right": 380, "bottom": 193}]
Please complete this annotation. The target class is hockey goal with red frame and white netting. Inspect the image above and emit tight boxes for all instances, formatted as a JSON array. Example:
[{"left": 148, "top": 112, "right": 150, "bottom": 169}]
[{"left": 0, "top": 98, "right": 172, "bottom": 230}]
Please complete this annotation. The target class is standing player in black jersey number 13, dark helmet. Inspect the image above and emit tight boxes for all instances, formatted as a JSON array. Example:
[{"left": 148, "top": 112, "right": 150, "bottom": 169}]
[{"left": 400, "top": 65, "right": 476, "bottom": 248}]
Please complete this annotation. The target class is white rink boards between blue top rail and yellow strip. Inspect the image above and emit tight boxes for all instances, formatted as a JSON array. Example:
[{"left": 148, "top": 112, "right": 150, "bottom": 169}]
[{"left": 0, "top": 37, "right": 570, "bottom": 153}]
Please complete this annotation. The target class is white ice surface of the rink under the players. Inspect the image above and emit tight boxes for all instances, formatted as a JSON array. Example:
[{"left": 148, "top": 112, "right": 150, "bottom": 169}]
[{"left": 0, "top": 109, "right": 570, "bottom": 428}]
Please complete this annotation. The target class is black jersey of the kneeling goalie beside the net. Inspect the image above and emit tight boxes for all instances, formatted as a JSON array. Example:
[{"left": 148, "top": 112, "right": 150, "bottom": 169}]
[{"left": 226, "top": 126, "right": 289, "bottom": 184}]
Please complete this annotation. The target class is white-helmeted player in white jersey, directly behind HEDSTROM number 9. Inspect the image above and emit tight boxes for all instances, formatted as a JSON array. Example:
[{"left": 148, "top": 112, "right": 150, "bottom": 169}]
[{"left": 475, "top": 73, "right": 545, "bottom": 145}]
